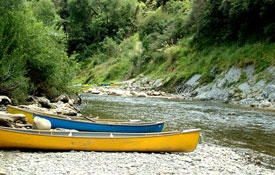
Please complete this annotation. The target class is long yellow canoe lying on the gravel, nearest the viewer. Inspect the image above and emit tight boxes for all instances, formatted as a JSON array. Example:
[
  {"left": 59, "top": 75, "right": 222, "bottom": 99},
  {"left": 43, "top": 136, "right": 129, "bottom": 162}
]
[{"left": 0, "top": 127, "right": 200, "bottom": 152}]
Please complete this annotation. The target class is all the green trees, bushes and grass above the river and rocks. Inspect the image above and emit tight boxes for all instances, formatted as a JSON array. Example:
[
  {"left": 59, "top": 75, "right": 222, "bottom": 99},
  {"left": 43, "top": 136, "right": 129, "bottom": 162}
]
[{"left": 0, "top": 0, "right": 275, "bottom": 102}]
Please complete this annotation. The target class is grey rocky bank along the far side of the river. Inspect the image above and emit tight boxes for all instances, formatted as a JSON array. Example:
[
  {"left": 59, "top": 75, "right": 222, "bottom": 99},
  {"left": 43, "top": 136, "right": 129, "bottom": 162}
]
[{"left": 85, "top": 64, "right": 275, "bottom": 110}]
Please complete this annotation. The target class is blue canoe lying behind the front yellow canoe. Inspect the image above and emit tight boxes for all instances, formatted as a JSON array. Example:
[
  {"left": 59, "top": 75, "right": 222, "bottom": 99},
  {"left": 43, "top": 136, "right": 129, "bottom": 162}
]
[{"left": 34, "top": 113, "right": 164, "bottom": 133}]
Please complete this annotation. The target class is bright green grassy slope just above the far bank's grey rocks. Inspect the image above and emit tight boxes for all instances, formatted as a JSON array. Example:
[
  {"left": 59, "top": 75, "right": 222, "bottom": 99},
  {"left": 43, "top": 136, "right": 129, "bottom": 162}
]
[{"left": 75, "top": 33, "right": 275, "bottom": 90}]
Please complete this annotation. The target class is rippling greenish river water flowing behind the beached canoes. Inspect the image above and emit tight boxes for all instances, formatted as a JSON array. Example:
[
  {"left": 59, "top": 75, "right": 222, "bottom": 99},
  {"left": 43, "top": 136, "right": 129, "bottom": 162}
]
[{"left": 80, "top": 94, "right": 275, "bottom": 169}]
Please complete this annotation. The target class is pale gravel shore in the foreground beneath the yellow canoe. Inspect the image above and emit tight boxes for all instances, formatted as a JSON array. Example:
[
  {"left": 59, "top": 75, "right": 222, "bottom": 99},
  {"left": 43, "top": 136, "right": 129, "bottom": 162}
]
[{"left": 0, "top": 143, "right": 274, "bottom": 175}]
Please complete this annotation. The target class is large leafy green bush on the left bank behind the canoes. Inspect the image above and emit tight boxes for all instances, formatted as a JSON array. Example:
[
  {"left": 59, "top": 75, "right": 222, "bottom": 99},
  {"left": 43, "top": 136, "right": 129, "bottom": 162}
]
[{"left": 0, "top": 1, "right": 75, "bottom": 103}]
